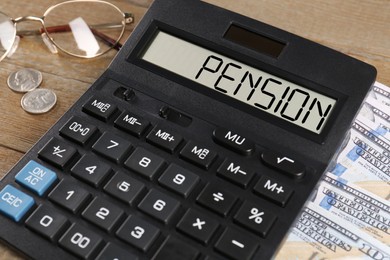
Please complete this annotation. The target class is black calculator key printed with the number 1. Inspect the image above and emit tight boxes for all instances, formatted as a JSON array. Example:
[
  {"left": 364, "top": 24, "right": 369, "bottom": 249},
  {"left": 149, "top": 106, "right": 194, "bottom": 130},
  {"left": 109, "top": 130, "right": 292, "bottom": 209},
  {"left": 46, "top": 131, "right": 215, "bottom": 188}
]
[{"left": 49, "top": 180, "right": 90, "bottom": 213}]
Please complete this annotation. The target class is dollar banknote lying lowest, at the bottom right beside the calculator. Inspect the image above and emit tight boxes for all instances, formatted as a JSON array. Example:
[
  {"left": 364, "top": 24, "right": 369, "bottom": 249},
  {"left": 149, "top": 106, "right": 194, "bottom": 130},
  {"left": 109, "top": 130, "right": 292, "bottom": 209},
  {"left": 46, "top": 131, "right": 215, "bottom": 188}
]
[{"left": 274, "top": 202, "right": 390, "bottom": 260}]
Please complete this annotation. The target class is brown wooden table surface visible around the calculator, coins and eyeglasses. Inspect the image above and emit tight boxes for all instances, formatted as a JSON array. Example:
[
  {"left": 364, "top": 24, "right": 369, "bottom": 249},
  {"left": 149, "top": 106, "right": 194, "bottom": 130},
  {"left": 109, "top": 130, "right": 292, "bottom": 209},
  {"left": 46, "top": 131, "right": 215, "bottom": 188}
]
[{"left": 0, "top": 0, "right": 390, "bottom": 259}]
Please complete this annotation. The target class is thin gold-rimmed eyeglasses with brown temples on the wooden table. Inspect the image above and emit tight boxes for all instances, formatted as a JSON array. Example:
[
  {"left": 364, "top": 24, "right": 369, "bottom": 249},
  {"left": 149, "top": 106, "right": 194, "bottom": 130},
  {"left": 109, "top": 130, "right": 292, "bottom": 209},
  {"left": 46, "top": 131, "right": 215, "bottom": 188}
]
[{"left": 0, "top": 0, "right": 134, "bottom": 61}]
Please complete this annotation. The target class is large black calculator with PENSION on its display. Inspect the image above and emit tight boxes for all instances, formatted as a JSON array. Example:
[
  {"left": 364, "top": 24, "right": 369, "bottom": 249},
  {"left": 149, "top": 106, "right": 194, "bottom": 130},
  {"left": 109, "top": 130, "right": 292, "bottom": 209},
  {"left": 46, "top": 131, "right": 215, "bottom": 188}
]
[{"left": 0, "top": 0, "right": 376, "bottom": 260}]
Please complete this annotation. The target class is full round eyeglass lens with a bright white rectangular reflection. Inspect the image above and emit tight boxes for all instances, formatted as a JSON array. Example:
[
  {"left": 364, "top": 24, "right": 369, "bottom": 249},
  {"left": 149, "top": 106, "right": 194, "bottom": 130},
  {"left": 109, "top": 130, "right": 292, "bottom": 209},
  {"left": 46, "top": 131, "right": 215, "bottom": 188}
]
[{"left": 44, "top": 1, "right": 125, "bottom": 57}]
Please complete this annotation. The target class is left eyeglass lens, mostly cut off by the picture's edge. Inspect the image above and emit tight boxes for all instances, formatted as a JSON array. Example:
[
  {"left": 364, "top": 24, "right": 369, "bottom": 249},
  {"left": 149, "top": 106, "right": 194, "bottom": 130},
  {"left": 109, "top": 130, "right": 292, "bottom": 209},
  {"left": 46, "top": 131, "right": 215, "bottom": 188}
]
[{"left": 0, "top": 12, "right": 16, "bottom": 60}]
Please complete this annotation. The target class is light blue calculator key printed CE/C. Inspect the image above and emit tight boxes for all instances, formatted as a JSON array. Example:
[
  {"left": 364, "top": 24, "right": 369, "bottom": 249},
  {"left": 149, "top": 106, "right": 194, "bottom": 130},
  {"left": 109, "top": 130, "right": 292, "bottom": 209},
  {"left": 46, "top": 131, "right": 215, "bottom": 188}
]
[{"left": 0, "top": 185, "right": 34, "bottom": 222}]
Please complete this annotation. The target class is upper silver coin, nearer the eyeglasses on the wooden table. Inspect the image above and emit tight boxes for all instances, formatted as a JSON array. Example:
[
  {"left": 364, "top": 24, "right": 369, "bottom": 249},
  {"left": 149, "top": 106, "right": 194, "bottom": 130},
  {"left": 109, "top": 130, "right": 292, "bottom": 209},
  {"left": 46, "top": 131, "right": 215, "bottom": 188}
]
[{"left": 7, "top": 69, "right": 42, "bottom": 92}]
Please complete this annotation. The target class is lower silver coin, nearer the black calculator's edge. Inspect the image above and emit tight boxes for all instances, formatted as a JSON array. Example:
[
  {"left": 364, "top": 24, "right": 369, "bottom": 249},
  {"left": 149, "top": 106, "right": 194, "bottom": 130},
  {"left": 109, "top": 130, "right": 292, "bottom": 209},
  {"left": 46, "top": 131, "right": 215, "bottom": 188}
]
[{"left": 20, "top": 88, "right": 57, "bottom": 114}]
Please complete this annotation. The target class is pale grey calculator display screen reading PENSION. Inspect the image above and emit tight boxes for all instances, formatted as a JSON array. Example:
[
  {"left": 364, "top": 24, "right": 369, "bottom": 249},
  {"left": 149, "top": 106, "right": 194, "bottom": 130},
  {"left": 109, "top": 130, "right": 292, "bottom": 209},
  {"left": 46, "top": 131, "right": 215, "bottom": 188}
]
[{"left": 141, "top": 31, "right": 336, "bottom": 134}]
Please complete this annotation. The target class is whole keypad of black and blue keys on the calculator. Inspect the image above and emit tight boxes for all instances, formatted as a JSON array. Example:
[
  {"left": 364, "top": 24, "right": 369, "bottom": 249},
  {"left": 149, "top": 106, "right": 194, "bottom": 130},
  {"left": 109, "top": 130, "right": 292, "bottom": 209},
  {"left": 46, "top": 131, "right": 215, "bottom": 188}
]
[{"left": 0, "top": 92, "right": 305, "bottom": 260}]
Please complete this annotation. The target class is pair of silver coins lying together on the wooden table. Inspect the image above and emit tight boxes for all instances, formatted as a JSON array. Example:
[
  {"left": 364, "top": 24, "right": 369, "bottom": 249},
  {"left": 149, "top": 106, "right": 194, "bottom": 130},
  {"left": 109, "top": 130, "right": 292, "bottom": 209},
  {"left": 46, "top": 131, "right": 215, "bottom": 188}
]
[{"left": 7, "top": 69, "right": 57, "bottom": 114}]
